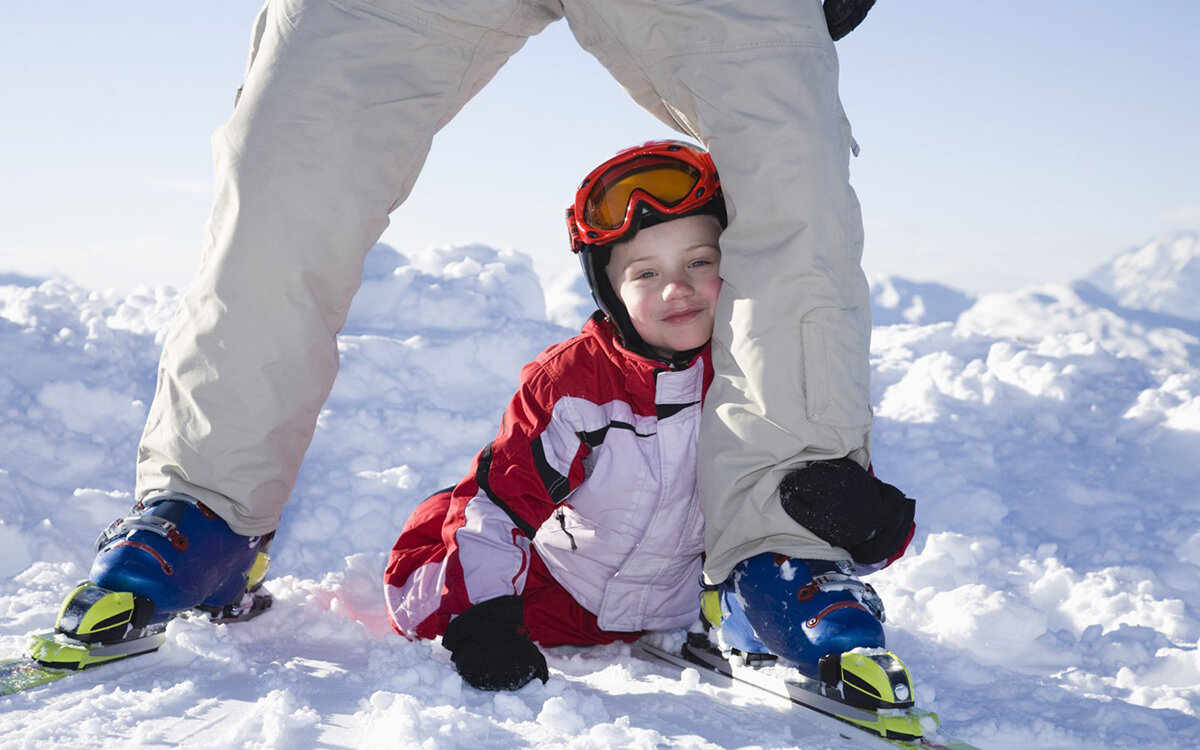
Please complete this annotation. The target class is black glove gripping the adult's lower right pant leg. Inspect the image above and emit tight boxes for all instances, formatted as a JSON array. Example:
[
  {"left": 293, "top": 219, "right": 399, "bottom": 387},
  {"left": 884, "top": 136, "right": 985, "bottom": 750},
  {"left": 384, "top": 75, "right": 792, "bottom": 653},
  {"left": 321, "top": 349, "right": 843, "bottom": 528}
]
[{"left": 779, "top": 458, "right": 917, "bottom": 565}]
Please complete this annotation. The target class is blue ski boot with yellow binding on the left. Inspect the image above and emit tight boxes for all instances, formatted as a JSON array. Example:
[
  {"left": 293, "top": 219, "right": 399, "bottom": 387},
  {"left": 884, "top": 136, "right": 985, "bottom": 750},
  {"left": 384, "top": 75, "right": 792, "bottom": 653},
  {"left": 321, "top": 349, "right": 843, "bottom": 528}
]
[{"left": 30, "top": 492, "right": 274, "bottom": 670}]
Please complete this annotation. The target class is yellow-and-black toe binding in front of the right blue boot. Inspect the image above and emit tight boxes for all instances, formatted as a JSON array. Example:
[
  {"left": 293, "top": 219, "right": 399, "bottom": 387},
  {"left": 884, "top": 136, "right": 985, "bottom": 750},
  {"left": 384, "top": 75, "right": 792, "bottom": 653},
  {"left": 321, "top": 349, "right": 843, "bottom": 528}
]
[{"left": 818, "top": 650, "right": 938, "bottom": 739}]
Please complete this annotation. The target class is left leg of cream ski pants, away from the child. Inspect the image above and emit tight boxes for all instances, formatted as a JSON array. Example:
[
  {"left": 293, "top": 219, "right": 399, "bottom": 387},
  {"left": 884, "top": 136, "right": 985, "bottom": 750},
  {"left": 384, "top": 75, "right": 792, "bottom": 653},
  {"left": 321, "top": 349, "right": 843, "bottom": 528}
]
[{"left": 137, "top": 0, "right": 562, "bottom": 535}]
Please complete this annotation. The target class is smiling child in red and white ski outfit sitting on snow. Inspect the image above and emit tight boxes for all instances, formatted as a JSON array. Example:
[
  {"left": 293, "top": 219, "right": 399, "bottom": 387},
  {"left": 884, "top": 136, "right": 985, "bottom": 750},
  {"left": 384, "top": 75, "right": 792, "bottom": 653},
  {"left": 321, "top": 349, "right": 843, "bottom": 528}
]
[{"left": 384, "top": 142, "right": 726, "bottom": 690}]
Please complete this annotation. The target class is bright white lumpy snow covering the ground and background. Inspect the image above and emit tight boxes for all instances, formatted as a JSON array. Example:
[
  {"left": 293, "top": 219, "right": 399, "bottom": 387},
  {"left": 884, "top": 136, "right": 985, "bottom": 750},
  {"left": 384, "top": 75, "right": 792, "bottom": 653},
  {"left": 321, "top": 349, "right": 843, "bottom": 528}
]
[{"left": 0, "top": 235, "right": 1200, "bottom": 749}]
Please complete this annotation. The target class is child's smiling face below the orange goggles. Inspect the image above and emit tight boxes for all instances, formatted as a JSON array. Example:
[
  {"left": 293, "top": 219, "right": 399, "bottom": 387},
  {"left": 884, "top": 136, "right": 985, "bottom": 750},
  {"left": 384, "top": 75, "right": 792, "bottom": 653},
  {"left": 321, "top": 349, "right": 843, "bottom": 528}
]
[{"left": 605, "top": 216, "right": 721, "bottom": 359}]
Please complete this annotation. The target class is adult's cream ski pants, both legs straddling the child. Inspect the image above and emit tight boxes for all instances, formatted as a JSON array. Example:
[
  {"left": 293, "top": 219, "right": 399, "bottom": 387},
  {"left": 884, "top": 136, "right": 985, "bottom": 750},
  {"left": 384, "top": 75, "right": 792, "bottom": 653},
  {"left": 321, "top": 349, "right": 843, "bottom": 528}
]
[{"left": 137, "top": 0, "right": 870, "bottom": 581}]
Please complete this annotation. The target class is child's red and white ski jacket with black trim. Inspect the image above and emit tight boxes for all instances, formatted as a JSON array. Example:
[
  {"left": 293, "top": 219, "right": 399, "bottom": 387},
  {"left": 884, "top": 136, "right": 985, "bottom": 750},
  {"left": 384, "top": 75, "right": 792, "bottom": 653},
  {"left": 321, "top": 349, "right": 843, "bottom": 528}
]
[{"left": 440, "top": 317, "right": 713, "bottom": 631}]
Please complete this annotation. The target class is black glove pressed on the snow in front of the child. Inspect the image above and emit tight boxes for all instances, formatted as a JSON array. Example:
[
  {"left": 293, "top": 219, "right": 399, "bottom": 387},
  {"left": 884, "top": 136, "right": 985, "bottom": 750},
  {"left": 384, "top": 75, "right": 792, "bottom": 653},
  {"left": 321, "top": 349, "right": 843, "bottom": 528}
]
[{"left": 442, "top": 596, "right": 550, "bottom": 690}]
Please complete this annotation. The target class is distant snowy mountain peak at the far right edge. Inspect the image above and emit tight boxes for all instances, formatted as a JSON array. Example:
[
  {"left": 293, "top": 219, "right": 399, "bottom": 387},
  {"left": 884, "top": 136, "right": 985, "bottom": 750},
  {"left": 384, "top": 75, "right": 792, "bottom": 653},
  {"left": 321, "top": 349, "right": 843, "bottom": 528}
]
[{"left": 1086, "top": 232, "right": 1200, "bottom": 320}]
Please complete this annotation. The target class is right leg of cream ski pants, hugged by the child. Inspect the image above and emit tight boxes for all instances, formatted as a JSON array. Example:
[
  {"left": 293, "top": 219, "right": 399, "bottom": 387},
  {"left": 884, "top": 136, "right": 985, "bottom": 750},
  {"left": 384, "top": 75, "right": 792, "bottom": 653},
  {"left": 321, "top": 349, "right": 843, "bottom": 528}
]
[{"left": 564, "top": 0, "right": 871, "bottom": 582}]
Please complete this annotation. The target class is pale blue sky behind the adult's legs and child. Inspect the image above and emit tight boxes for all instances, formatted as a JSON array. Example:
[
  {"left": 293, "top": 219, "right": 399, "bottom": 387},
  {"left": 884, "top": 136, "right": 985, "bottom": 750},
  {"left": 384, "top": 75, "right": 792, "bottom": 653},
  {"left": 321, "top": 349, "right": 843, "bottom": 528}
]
[{"left": 0, "top": 0, "right": 1200, "bottom": 292}]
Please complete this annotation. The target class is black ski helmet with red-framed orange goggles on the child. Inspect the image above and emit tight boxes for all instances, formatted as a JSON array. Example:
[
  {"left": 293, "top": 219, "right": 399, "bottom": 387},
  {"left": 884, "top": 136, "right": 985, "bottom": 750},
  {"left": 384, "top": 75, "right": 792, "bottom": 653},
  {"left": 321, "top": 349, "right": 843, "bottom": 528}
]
[{"left": 566, "top": 140, "right": 728, "bottom": 359}]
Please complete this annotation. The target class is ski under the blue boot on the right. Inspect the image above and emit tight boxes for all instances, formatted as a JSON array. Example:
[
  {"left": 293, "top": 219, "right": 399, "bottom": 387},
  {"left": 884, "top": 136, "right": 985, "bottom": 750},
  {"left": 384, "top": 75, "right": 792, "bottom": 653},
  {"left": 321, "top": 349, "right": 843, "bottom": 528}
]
[{"left": 635, "top": 634, "right": 978, "bottom": 750}]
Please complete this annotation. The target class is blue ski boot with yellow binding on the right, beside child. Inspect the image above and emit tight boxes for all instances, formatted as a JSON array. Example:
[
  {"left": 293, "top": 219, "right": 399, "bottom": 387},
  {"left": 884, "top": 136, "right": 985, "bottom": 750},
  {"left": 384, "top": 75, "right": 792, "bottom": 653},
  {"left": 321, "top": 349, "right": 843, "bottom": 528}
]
[{"left": 700, "top": 553, "right": 921, "bottom": 739}]
